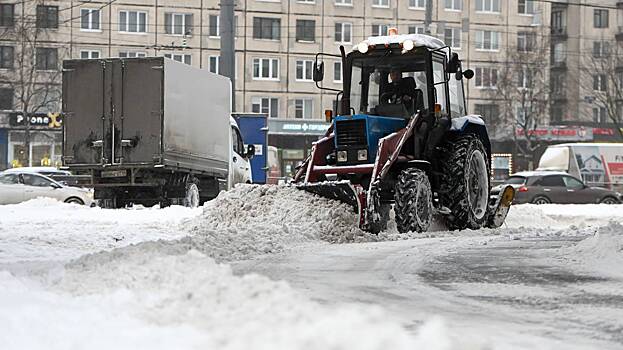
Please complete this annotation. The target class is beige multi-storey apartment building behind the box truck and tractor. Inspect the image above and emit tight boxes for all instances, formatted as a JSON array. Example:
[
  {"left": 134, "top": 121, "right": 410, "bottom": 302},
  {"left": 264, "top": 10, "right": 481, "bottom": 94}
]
[{"left": 0, "top": 0, "right": 550, "bottom": 172}]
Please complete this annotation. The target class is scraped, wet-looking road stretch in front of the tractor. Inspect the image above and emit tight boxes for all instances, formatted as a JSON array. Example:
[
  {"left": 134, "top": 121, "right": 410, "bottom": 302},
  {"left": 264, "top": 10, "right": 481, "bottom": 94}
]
[{"left": 235, "top": 237, "right": 623, "bottom": 349}]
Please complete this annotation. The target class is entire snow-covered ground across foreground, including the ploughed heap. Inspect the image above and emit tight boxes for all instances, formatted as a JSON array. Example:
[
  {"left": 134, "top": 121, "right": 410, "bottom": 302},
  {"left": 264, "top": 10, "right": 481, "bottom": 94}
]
[{"left": 0, "top": 187, "right": 623, "bottom": 350}]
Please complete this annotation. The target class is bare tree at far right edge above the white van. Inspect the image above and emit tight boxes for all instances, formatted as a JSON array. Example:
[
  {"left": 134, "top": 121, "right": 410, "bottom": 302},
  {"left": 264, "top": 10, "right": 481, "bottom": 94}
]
[{"left": 580, "top": 41, "right": 623, "bottom": 140}]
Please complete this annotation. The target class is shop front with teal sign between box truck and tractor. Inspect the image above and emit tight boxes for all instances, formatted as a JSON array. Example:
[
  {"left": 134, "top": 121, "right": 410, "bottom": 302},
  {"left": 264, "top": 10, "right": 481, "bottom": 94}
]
[{"left": 268, "top": 119, "right": 330, "bottom": 179}]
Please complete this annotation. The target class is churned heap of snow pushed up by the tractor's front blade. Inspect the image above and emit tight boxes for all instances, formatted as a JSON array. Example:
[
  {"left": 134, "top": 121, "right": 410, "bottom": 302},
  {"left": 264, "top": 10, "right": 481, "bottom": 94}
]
[{"left": 183, "top": 185, "right": 363, "bottom": 260}]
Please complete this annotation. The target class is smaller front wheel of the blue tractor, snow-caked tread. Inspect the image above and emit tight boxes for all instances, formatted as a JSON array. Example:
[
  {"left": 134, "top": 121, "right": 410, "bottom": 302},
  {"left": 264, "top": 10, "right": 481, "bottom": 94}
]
[{"left": 394, "top": 169, "right": 433, "bottom": 233}]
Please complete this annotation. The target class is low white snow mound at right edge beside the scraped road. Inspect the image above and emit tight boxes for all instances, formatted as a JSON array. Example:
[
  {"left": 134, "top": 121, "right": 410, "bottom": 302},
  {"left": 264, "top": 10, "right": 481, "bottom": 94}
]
[{"left": 560, "top": 221, "right": 623, "bottom": 278}]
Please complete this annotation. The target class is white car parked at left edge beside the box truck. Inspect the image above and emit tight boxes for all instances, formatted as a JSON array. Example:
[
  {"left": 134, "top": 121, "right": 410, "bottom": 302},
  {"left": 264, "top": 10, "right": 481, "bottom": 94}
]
[{"left": 0, "top": 171, "right": 96, "bottom": 207}]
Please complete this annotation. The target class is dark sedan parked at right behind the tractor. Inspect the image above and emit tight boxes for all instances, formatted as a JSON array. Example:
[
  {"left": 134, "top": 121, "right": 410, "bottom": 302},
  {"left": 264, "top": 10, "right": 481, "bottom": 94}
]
[{"left": 491, "top": 171, "right": 623, "bottom": 204}]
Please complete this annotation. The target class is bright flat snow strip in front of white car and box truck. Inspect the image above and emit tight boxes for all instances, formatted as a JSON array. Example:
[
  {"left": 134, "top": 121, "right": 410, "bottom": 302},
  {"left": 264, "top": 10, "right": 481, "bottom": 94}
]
[{"left": 0, "top": 198, "right": 201, "bottom": 263}]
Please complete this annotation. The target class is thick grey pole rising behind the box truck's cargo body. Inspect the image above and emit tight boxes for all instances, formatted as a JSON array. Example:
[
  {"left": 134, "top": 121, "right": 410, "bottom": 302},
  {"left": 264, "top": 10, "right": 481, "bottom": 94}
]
[{"left": 219, "top": 0, "right": 236, "bottom": 112}]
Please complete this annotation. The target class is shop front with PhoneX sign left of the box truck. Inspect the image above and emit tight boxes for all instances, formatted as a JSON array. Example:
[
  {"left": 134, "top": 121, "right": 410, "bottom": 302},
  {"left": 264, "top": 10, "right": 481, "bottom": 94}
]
[{"left": 6, "top": 112, "right": 63, "bottom": 168}]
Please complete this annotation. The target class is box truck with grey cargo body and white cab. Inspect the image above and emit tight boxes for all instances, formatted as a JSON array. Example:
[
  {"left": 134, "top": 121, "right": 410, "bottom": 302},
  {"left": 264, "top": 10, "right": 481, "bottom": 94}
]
[{"left": 63, "top": 57, "right": 254, "bottom": 207}]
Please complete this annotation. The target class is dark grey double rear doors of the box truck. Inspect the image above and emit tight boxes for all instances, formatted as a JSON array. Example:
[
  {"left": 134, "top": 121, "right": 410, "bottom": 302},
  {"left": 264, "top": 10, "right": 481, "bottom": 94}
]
[{"left": 63, "top": 58, "right": 163, "bottom": 165}]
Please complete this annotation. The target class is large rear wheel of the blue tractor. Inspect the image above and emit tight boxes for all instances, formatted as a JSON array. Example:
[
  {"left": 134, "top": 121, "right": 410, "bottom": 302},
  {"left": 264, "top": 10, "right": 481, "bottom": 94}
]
[{"left": 439, "top": 135, "right": 490, "bottom": 230}]
